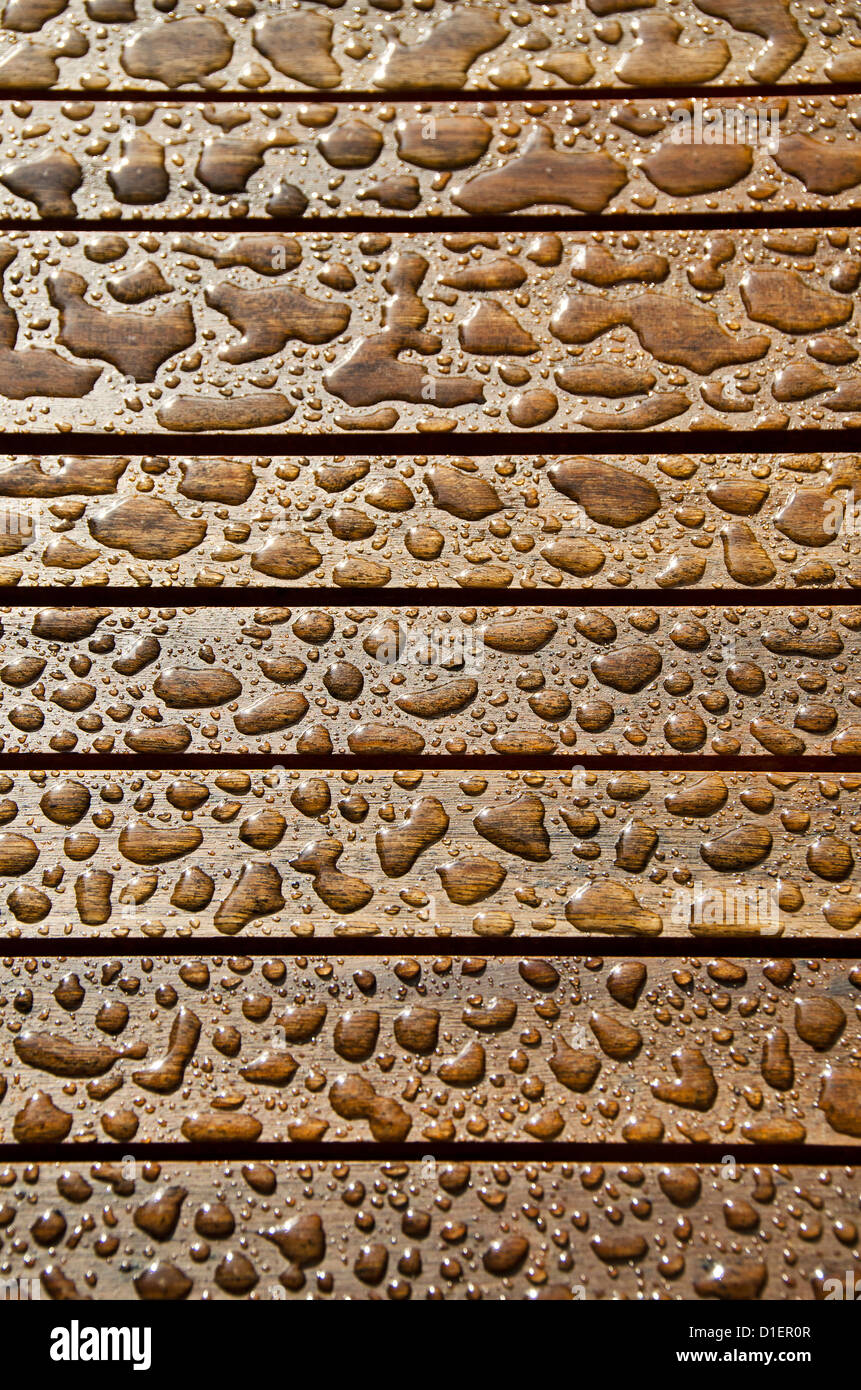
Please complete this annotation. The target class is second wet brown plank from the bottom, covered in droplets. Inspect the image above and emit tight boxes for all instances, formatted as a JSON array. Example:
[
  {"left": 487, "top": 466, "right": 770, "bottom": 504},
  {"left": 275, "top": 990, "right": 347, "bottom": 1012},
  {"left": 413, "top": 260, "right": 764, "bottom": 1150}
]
[{"left": 0, "top": 950, "right": 861, "bottom": 1156}]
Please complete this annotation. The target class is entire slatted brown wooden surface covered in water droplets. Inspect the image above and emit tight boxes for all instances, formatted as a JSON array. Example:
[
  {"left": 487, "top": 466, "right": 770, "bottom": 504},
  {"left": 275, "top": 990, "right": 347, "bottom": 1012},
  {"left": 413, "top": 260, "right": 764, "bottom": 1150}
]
[{"left": 0, "top": 0, "right": 861, "bottom": 1300}]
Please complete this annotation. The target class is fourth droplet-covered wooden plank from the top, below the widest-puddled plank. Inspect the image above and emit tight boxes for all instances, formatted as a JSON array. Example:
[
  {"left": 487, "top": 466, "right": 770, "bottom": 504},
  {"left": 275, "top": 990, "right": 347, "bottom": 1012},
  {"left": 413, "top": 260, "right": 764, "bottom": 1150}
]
[{"left": 0, "top": 453, "right": 861, "bottom": 591}]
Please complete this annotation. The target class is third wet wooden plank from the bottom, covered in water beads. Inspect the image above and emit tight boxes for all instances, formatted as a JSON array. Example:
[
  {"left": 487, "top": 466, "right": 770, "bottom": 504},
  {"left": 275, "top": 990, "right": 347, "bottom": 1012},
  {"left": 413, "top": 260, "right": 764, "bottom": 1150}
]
[{"left": 0, "top": 769, "right": 861, "bottom": 945}]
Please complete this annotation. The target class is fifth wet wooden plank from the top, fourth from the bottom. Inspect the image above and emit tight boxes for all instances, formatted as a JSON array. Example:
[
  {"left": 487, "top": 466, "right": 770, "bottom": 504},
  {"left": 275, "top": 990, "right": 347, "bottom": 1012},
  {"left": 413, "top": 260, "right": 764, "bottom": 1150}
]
[{"left": 0, "top": 600, "right": 861, "bottom": 770}]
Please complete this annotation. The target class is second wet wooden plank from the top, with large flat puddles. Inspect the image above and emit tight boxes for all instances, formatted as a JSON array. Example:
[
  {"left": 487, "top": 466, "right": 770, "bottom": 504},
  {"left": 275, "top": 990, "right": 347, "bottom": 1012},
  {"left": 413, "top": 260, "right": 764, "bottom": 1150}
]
[{"left": 0, "top": 96, "right": 861, "bottom": 224}]
